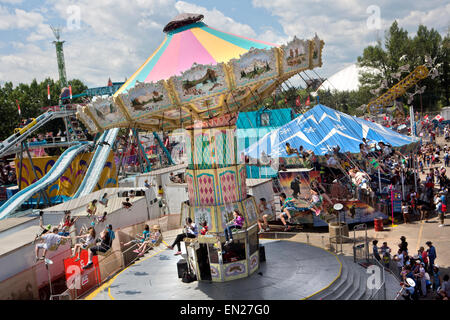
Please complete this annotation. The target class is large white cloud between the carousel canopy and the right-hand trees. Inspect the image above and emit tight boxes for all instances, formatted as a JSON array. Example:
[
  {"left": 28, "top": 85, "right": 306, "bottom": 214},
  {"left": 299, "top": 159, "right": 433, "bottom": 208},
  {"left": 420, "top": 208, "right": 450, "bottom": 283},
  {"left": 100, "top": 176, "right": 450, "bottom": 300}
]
[{"left": 252, "top": 0, "right": 450, "bottom": 77}]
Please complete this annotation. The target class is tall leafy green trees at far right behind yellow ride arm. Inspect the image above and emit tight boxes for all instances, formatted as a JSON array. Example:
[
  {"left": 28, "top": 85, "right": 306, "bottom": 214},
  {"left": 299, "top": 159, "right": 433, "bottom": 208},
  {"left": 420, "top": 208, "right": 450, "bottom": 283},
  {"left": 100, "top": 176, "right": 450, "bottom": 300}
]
[{"left": 358, "top": 21, "right": 448, "bottom": 111}]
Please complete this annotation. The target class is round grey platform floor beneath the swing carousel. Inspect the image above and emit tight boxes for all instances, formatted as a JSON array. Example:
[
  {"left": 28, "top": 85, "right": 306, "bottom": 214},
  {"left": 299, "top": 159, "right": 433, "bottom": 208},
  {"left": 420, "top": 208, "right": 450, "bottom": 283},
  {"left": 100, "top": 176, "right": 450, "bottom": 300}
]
[{"left": 92, "top": 240, "right": 341, "bottom": 300}]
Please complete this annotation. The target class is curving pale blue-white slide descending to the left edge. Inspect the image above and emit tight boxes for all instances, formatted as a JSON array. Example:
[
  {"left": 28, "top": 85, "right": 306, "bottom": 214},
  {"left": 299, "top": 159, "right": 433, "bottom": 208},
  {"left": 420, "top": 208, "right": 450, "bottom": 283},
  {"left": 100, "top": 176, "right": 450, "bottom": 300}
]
[{"left": 0, "top": 142, "right": 92, "bottom": 220}]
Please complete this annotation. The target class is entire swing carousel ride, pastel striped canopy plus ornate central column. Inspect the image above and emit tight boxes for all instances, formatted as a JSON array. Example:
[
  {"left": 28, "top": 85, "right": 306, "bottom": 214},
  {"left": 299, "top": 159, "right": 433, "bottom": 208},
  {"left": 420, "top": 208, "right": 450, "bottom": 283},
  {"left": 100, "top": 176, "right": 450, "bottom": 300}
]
[{"left": 78, "top": 13, "right": 324, "bottom": 282}]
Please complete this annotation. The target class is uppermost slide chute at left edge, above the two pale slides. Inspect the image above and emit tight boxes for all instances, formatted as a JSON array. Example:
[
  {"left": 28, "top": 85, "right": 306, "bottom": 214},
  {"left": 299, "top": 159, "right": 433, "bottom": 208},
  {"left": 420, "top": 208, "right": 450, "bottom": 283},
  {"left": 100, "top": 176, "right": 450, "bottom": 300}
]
[{"left": 0, "top": 110, "right": 75, "bottom": 157}]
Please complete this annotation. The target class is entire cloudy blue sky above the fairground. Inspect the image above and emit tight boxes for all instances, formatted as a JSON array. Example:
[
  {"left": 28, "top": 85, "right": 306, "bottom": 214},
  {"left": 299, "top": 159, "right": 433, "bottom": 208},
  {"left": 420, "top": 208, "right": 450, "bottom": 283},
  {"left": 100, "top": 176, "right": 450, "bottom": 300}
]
[{"left": 0, "top": 0, "right": 450, "bottom": 86}]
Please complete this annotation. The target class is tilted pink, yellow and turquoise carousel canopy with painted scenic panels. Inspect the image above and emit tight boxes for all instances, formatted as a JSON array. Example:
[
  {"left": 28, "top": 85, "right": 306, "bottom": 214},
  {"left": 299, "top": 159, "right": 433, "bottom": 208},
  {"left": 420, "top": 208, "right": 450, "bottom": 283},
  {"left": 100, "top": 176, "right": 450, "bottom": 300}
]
[{"left": 78, "top": 14, "right": 323, "bottom": 132}]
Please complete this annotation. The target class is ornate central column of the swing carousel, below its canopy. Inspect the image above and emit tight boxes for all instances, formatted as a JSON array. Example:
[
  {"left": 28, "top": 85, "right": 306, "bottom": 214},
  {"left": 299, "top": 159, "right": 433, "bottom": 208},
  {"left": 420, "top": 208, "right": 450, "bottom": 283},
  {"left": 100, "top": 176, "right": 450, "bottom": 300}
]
[{"left": 182, "top": 113, "right": 259, "bottom": 282}]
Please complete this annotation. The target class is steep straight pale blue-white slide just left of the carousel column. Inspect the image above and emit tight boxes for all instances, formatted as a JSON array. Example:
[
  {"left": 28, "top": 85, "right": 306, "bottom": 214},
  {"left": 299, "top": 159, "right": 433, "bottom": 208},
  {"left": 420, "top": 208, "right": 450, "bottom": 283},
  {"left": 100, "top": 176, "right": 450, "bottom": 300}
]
[{"left": 72, "top": 128, "right": 119, "bottom": 199}]
